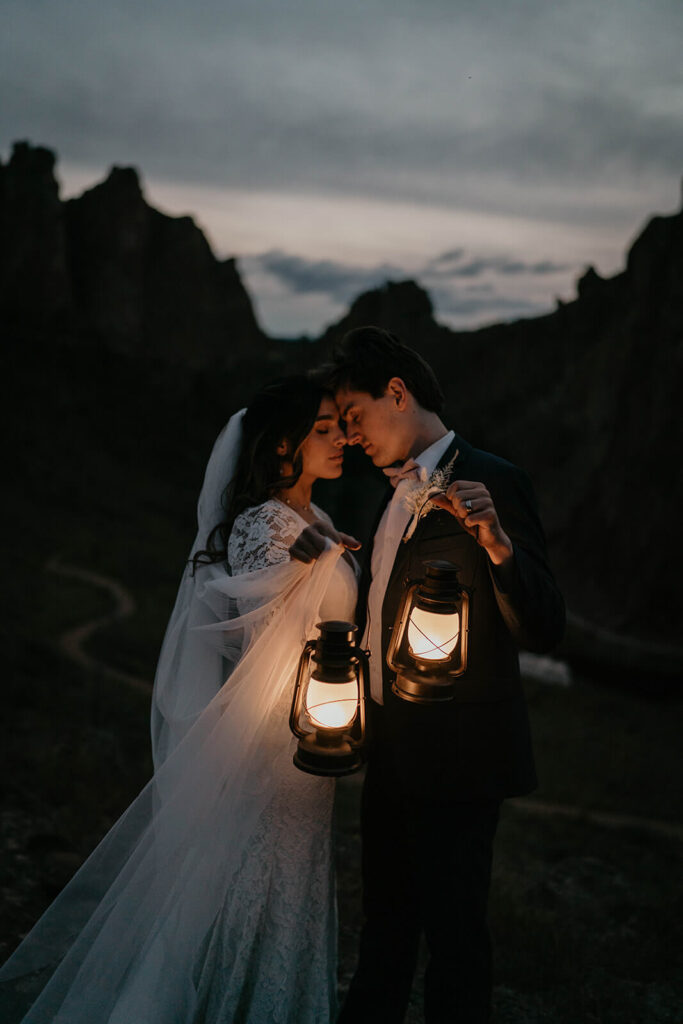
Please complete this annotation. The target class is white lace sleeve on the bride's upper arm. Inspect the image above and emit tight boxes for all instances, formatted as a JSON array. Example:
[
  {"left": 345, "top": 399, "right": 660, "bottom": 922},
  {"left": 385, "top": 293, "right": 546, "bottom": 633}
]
[{"left": 227, "top": 499, "right": 303, "bottom": 575}]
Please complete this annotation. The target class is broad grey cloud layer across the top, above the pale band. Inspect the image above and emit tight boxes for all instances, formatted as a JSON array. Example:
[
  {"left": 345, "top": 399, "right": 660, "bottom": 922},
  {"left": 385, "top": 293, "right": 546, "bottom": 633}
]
[{"left": 0, "top": 0, "right": 683, "bottom": 230}]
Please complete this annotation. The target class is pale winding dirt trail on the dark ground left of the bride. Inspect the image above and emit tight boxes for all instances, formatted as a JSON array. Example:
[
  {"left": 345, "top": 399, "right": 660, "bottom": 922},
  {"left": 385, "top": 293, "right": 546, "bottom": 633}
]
[{"left": 46, "top": 556, "right": 152, "bottom": 694}]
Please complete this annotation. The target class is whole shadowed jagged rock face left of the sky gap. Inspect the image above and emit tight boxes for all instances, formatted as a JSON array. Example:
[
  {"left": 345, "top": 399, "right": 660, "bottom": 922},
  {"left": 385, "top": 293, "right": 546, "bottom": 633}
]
[{"left": 0, "top": 143, "right": 270, "bottom": 369}]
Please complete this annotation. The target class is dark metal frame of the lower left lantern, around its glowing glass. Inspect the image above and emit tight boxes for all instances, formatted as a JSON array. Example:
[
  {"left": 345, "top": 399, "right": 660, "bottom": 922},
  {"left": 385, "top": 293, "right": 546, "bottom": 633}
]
[{"left": 290, "top": 620, "right": 369, "bottom": 777}]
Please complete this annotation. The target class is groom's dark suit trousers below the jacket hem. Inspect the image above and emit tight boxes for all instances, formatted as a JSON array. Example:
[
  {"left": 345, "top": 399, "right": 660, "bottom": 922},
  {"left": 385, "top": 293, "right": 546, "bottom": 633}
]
[{"left": 338, "top": 755, "right": 500, "bottom": 1024}]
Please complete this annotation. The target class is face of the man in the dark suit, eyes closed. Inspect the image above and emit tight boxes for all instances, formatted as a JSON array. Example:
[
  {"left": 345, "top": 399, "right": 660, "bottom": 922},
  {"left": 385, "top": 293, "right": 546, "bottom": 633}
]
[{"left": 335, "top": 388, "right": 410, "bottom": 466}]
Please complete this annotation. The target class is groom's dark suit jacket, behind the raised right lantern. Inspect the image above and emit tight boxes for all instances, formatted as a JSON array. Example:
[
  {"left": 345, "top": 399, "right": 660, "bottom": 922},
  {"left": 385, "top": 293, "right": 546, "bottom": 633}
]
[{"left": 361, "top": 428, "right": 564, "bottom": 801}]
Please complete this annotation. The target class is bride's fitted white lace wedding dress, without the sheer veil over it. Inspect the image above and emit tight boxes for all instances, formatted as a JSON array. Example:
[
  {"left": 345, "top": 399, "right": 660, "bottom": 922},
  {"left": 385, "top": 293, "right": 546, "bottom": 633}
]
[{"left": 194, "top": 500, "right": 356, "bottom": 1024}]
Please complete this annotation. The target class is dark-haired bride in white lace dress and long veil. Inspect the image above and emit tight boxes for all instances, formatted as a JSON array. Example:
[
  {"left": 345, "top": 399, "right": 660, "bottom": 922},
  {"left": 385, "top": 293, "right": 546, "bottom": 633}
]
[{"left": 0, "top": 376, "right": 358, "bottom": 1024}]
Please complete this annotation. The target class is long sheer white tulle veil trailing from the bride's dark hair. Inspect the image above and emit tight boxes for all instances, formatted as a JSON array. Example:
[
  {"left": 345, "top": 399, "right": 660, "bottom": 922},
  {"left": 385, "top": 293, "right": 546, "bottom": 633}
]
[{"left": 0, "top": 411, "right": 342, "bottom": 1024}]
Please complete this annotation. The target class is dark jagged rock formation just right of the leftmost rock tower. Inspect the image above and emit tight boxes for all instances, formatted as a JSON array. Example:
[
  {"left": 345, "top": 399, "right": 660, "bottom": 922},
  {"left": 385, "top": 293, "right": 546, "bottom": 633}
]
[{"left": 67, "top": 167, "right": 265, "bottom": 367}]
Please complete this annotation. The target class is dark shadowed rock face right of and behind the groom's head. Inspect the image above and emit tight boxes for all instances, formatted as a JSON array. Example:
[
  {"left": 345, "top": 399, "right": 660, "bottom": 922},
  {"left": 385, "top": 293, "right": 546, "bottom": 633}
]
[{"left": 323, "top": 212, "right": 683, "bottom": 655}]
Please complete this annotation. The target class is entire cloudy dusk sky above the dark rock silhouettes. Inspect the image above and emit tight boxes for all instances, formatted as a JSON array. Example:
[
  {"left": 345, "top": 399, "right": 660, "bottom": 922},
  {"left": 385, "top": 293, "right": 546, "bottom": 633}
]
[{"left": 0, "top": 0, "right": 683, "bottom": 335}]
